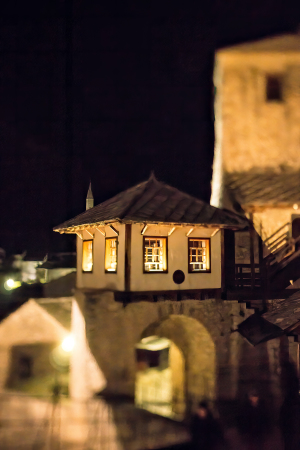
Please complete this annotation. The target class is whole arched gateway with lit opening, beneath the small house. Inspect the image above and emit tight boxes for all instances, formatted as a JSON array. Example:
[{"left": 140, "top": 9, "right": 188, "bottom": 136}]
[{"left": 135, "top": 315, "right": 216, "bottom": 418}]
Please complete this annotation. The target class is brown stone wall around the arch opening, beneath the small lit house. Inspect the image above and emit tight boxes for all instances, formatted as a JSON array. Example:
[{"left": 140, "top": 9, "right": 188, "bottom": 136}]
[{"left": 74, "top": 291, "right": 279, "bottom": 408}]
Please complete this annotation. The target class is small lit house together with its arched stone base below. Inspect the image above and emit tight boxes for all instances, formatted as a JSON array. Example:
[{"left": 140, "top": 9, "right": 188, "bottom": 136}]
[{"left": 55, "top": 175, "right": 288, "bottom": 418}]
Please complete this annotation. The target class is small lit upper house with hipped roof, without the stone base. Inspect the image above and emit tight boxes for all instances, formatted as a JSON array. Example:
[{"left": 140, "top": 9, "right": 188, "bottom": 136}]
[{"left": 55, "top": 175, "right": 248, "bottom": 300}]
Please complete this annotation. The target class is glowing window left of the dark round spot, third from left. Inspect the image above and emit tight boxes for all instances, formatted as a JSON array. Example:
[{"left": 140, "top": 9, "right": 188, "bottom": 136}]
[{"left": 144, "top": 237, "right": 167, "bottom": 272}]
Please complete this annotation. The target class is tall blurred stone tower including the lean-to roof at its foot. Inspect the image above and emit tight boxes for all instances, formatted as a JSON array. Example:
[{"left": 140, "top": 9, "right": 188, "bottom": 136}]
[{"left": 211, "top": 34, "right": 300, "bottom": 240}]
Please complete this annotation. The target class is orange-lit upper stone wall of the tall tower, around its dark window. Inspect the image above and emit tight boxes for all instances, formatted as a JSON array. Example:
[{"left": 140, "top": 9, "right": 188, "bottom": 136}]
[{"left": 215, "top": 50, "right": 300, "bottom": 172}]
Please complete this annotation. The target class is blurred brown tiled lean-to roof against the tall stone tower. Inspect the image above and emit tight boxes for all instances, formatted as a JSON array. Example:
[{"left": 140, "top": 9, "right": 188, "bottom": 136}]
[{"left": 224, "top": 169, "right": 300, "bottom": 206}]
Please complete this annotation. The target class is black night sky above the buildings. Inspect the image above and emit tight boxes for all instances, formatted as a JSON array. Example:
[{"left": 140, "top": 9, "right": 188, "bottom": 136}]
[{"left": 0, "top": 0, "right": 300, "bottom": 252}]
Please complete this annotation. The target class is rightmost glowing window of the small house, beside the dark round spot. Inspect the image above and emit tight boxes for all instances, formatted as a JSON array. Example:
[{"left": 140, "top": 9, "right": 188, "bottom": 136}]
[{"left": 188, "top": 238, "right": 210, "bottom": 272}]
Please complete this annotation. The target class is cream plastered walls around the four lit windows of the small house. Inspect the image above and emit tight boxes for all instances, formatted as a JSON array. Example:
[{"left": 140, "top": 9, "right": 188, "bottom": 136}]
[{"left": 77, "top": 224, "right": 221, "bottom": 291}]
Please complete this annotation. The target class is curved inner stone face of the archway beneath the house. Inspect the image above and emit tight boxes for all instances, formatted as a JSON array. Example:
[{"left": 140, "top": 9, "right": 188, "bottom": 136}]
[{"left": 136, "top": 315, "right": 216, "bottom": 411}]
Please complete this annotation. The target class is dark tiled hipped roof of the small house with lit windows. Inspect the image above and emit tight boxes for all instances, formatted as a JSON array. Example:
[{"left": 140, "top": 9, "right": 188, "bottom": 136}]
[{"left": 54, "top": 175, "right": 248, "bottom": 231}]
